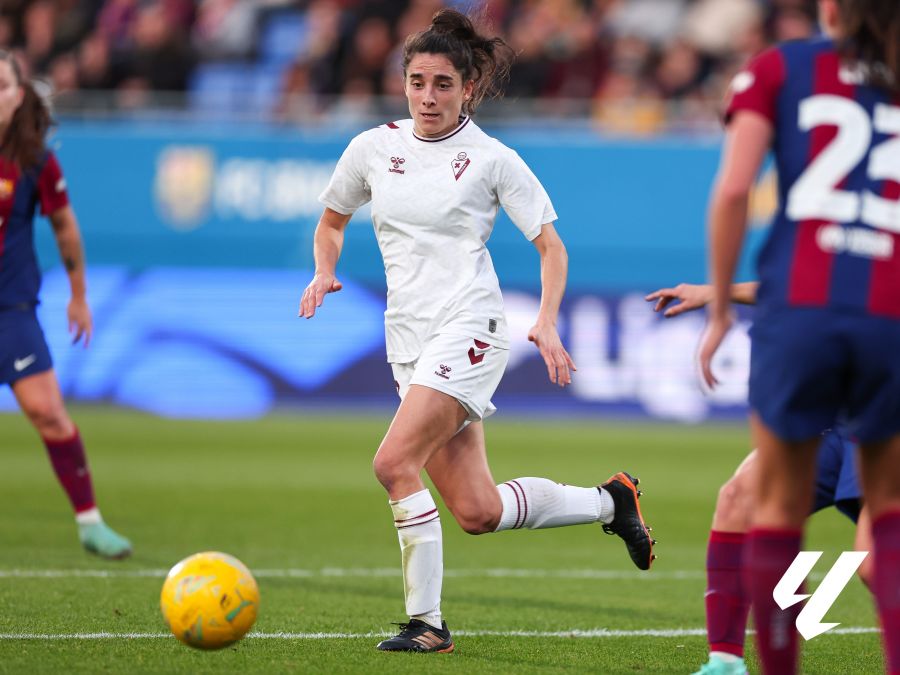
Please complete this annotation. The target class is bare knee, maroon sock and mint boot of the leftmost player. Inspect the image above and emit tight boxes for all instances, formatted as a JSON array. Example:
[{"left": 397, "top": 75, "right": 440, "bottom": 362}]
[{"left": 11, "top": 369, "right": 131, "bottom": 558}]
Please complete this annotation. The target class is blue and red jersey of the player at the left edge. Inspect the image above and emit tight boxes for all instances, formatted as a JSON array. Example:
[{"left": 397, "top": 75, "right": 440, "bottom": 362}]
[{"left": 0, "top": 151, "right": 69, "bottom": 309}]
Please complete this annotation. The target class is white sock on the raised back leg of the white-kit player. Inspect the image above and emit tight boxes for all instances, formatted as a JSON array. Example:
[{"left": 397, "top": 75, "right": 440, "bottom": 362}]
[{"left": 495, "top": 478, "right": 614, "bottom": 532}]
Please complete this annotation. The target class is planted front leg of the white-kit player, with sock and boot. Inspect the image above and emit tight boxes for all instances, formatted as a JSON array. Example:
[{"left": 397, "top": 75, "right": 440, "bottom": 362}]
[{"left": 373, "top": 382, "right": 468, "bottom": 652}]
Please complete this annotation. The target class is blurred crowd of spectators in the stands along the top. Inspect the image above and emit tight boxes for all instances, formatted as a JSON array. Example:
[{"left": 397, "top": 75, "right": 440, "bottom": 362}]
[{"left": 0, "top": 0, "right": 816, "bottom": 134}]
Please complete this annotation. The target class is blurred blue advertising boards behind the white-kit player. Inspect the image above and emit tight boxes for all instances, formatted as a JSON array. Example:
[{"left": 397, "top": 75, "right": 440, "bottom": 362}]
[{"left": 12, "top": 119, "right": 773, "bottom": 421}]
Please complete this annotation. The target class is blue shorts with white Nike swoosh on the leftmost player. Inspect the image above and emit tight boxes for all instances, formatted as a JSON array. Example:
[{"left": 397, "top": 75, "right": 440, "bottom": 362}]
[{"left": 0, "top": 308, "right": 53, "bottom": 384}]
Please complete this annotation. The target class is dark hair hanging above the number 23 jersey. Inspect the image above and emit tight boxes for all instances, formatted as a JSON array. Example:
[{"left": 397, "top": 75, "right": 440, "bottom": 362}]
[{"left": 840, "top": 0, "right": 900, "bottom": 92}]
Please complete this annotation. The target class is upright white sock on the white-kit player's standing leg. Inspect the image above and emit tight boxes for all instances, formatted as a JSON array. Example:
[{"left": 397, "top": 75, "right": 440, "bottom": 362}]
[{"left": 389, "top": 488, "right": 444, "bottom": 628}]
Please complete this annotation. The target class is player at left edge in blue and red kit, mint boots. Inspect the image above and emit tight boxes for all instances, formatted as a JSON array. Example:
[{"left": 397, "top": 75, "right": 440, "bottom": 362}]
[{"left": 0, "top": 50, "right": 131, "bottom": 558}]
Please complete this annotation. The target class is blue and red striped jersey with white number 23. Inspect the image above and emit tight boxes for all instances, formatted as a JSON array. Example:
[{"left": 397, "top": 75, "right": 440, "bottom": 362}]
[{"left": 726, "top": 39, "right": 900, "bottom": 319}]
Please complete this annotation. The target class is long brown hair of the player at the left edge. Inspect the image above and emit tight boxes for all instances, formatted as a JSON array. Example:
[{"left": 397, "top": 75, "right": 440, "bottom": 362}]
[{"left": 0, "top": 49, "right": 52, "bottom": 169}]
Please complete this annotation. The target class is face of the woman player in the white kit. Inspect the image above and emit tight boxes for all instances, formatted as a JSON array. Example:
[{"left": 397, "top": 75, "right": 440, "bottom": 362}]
[{"left": 404, "top": 54, "right": 475, "bottom": 138}]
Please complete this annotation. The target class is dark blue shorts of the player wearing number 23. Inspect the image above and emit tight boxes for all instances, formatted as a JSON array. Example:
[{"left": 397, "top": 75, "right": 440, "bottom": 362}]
[{"left": 750, "top": 308, "right": 900, "bottom": 443}]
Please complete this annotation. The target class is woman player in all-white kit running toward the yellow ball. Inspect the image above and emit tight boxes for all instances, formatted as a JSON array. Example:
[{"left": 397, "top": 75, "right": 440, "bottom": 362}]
[{"left": 300, "top": 9, "right": 654, "bottom": 652}]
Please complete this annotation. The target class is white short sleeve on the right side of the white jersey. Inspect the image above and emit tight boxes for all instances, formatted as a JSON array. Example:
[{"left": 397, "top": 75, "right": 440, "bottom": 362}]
[{"left": 497, "top": 146, "right": 557, "bottom": 241}]
